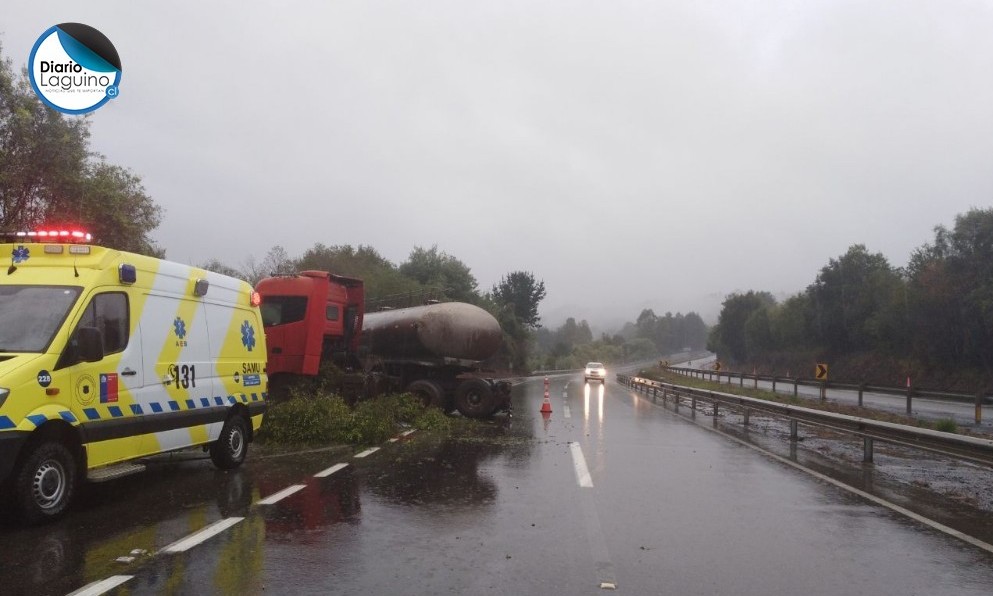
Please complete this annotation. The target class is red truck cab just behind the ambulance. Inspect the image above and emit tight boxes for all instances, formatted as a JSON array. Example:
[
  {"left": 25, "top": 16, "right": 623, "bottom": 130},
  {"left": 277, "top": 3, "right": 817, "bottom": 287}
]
[{"left": 256, "top": 271, "right": 365, "bottom": 375}]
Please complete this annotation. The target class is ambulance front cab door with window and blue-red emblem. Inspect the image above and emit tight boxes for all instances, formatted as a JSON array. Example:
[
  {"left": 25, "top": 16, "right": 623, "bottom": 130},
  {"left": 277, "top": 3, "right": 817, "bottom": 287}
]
[{"left": 57, "top": 288, "right": 144, "bottom": 468}]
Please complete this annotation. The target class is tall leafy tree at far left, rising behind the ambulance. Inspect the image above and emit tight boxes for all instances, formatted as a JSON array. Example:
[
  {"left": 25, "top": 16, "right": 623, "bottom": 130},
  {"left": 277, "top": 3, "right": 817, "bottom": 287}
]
[{"left": 0, "top": 43, "right": 164, "bottom": 256}]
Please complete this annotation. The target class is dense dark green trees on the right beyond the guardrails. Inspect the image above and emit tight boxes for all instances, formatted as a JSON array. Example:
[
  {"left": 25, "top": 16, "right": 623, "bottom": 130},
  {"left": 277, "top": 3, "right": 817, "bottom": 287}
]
[{"left": 708, "top": 208, "right": 993, "bottom": 392}]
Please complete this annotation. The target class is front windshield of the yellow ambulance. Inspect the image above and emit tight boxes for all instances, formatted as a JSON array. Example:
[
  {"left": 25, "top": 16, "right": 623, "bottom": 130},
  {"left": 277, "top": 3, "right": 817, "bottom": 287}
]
[{"left": 0, "top": 285, "right": 81, "bottom": 352}]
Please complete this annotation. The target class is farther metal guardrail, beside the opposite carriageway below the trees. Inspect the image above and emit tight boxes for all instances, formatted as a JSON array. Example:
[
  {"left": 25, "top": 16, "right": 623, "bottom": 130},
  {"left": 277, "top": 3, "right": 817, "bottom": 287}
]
[{"left": 666, "top": 366, "right": 993, "bottom": 424}]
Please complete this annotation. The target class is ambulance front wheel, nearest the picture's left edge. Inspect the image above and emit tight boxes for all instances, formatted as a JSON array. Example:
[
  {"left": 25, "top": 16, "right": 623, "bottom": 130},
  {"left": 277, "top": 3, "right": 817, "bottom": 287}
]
[{"left": 14, "top": 441, "right": 78, "bottom": 524}]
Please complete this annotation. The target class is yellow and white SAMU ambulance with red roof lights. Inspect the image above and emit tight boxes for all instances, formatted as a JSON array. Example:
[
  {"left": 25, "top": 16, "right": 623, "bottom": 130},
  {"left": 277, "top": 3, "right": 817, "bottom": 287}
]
[{"left": 0, "top": 229, "right": 268, "bottom": 523}]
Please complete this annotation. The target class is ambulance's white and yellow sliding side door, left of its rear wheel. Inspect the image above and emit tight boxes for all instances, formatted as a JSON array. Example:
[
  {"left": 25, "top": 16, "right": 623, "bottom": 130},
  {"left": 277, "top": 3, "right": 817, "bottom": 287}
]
[{"left": 141, "top": 292, "right": 215, "bottom": 453}]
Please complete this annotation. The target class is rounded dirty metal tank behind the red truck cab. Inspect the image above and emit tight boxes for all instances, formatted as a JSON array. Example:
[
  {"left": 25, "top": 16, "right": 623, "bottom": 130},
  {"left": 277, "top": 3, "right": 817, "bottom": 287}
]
[{"left": 360, "top": 302, "right": 503, "bottom": 361}]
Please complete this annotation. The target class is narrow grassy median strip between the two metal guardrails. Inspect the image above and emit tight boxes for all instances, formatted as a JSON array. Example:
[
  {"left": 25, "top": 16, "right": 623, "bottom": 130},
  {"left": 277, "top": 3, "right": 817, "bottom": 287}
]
[{"left": 638, "top": 368, "right": 968, "bottom": 434}]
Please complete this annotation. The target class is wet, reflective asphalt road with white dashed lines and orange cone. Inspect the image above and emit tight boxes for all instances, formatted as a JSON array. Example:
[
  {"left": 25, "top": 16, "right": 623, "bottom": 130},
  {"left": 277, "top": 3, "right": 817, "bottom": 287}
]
[{"left": 0, "top": 375, "right": 993, "bottom": 595}]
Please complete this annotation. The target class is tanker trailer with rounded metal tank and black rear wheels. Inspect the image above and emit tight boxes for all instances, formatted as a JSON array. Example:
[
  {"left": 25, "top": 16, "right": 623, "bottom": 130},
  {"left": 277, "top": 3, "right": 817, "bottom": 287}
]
[{"left": 359, "top": 302, "right": 511, "bottom": 418}]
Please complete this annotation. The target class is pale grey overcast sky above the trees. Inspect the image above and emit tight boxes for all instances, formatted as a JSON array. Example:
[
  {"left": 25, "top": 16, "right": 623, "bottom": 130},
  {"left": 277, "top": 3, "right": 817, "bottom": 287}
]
[{"left": 0, "top": 0, "right": 993, "bottom": 328}]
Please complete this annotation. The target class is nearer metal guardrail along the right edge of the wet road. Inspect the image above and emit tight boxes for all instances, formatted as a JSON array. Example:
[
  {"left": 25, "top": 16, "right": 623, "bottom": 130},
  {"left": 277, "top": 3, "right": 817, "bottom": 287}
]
[{"left": 617, "top": 374, "right": 993, "bottom": 466}]
